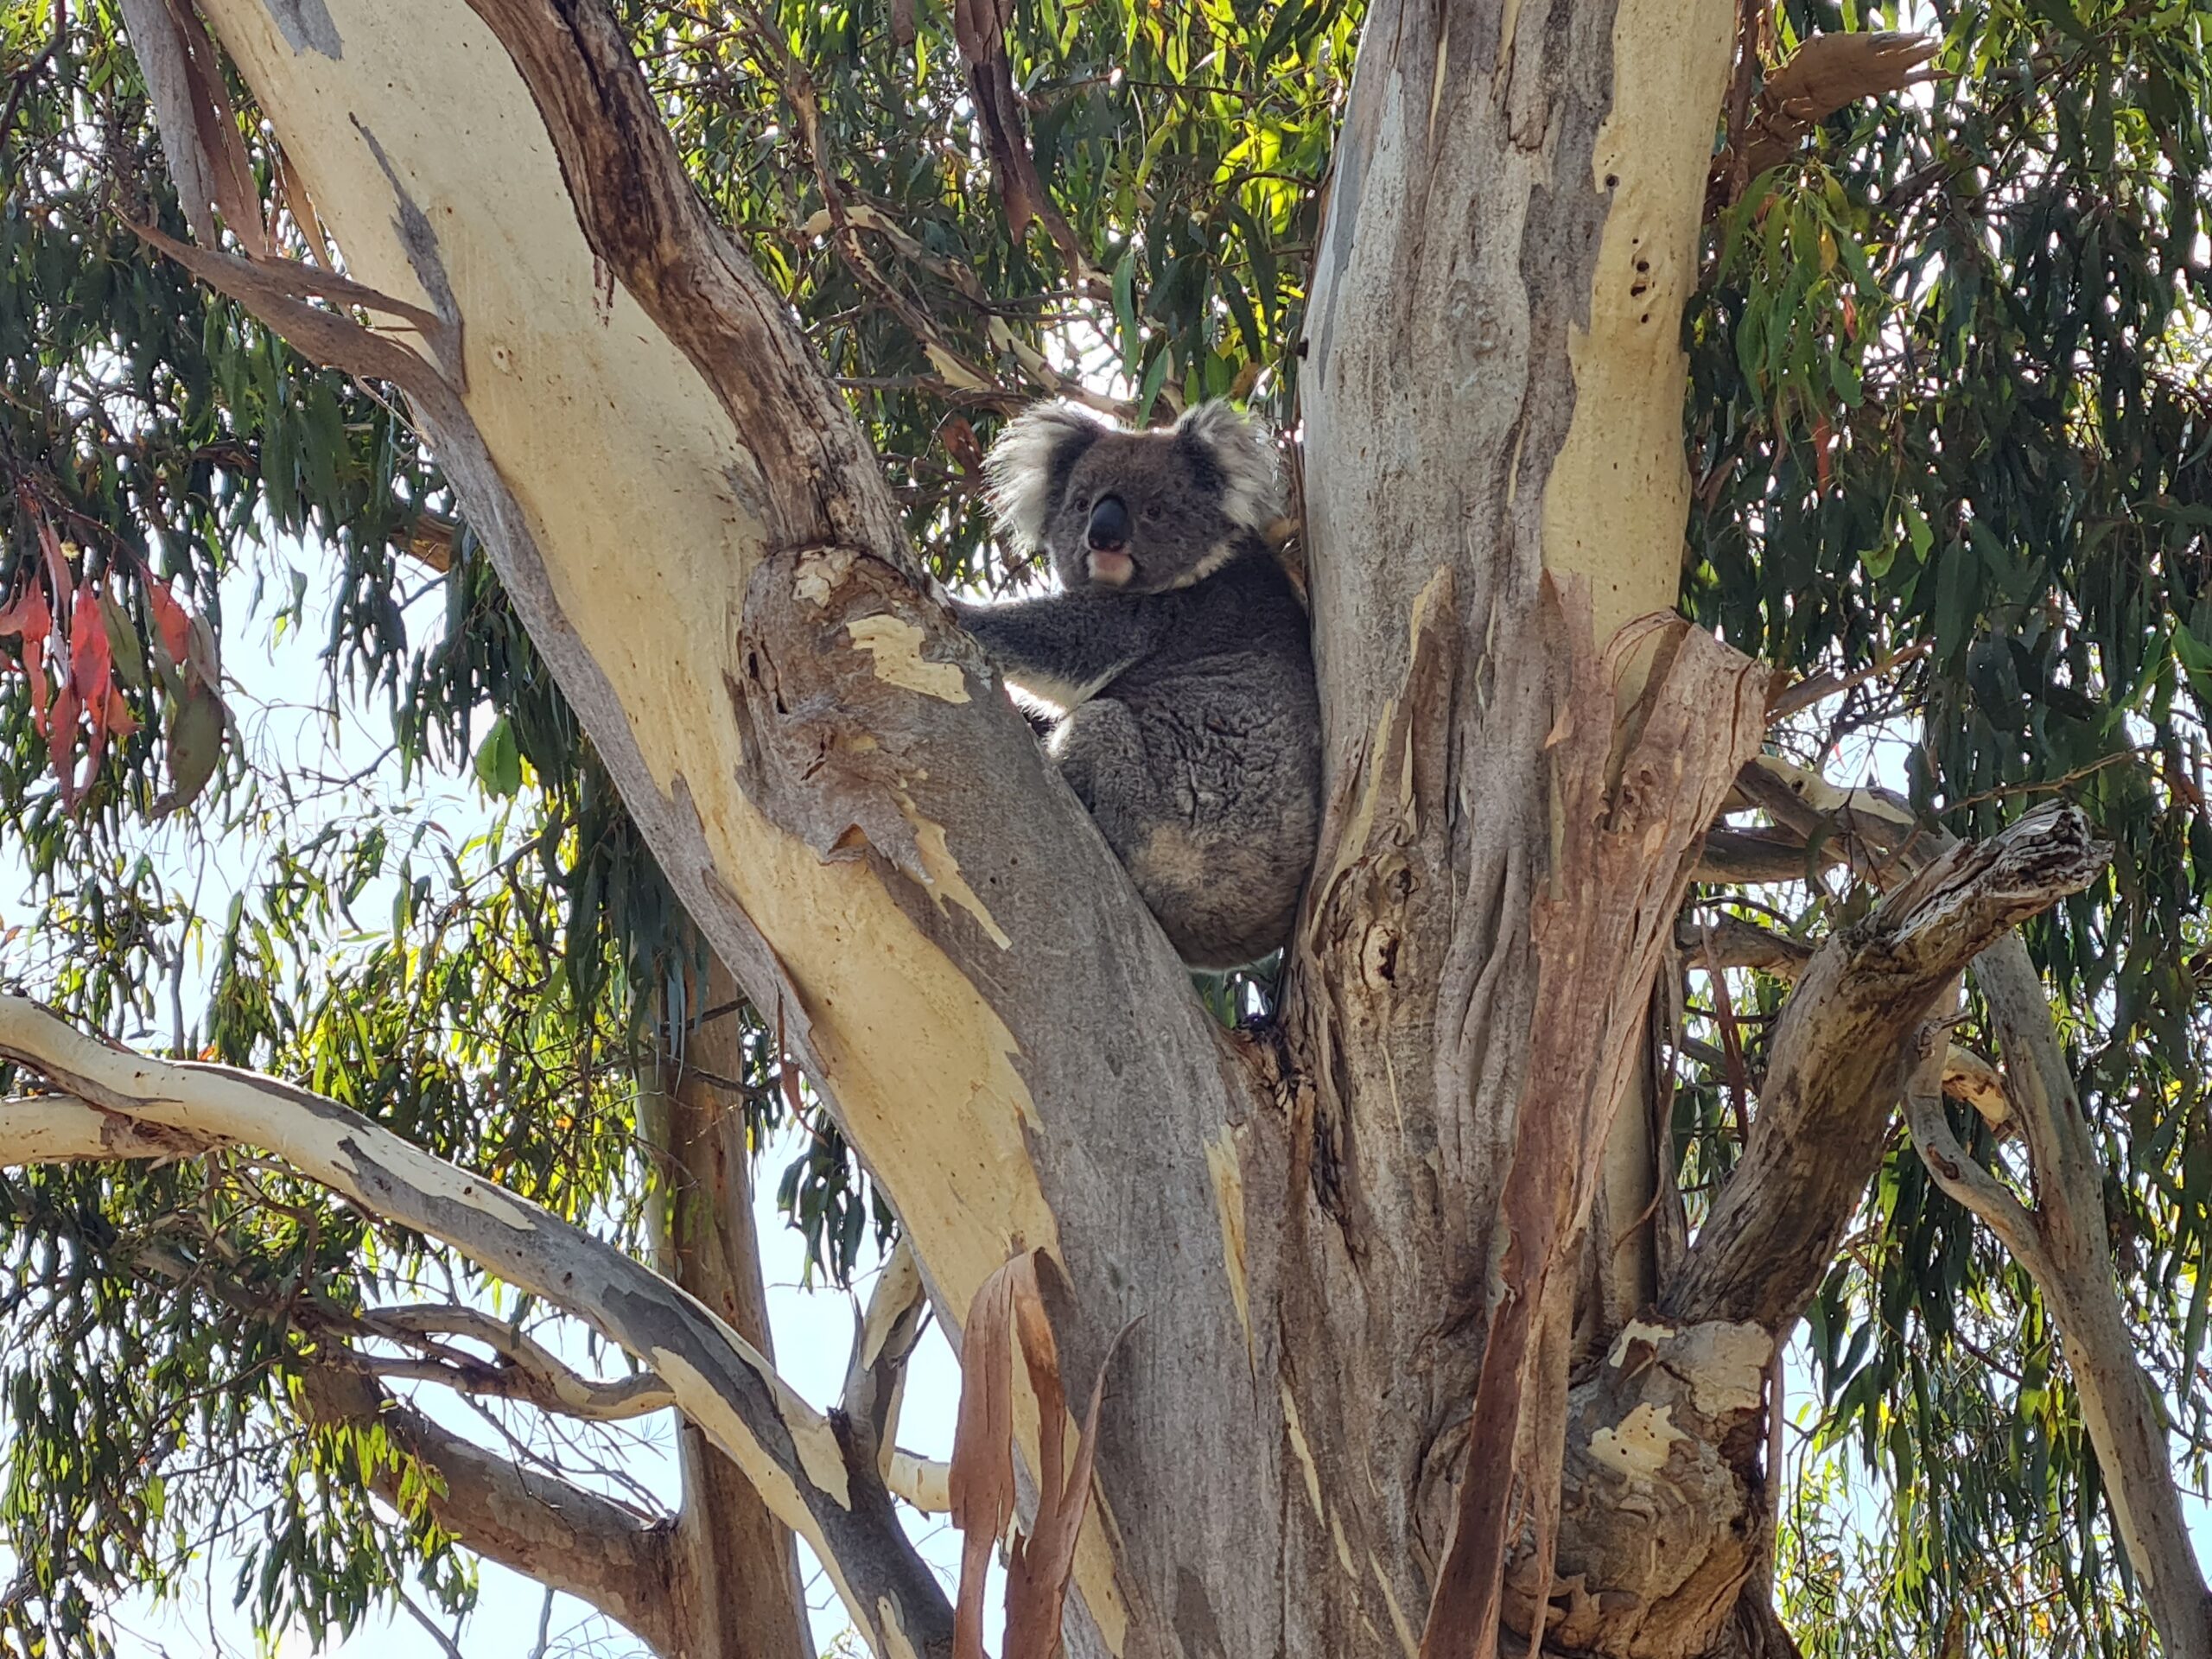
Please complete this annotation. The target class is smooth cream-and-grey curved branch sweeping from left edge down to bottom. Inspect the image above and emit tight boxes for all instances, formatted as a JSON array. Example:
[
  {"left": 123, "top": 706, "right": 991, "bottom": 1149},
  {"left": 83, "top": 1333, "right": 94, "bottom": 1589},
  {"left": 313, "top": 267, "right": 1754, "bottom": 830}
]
[{"left": 0, "top": 1013, "right": 951, "bottom": 1655}]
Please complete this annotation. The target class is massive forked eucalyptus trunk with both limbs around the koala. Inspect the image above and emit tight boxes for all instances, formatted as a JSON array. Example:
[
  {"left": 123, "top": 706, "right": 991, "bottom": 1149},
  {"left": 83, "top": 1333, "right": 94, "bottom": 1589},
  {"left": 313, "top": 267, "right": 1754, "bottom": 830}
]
[{"left": 86, "top": 0, "right": 2114, "bottom": 1659}]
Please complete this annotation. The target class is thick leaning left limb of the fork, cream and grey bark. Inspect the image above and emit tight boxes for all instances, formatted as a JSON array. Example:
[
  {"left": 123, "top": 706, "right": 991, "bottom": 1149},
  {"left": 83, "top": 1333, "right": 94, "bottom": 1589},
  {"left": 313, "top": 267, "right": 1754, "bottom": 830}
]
[{"left": 156, "top": 0, "right": 1281, "bottom": 1650}]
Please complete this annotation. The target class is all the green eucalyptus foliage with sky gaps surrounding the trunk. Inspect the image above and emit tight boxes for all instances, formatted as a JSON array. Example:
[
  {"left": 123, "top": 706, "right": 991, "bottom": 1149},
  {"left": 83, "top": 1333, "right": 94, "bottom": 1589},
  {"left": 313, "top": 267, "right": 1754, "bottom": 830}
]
[{"left": 0, "top": 0, "right": 2212, "bottom": 1659}]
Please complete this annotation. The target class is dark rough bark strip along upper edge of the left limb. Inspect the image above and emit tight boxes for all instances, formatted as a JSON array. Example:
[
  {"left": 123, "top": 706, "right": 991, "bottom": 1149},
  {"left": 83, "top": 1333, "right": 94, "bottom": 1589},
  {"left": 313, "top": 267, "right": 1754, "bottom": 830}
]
[{"left": 469, "top": 0, "right": 920, "bottom": 559}]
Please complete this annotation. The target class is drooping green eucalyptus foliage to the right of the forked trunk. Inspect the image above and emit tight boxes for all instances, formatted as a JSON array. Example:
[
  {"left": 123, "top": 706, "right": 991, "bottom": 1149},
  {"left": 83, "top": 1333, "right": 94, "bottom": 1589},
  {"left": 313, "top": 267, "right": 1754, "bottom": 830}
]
[{"left": 1683, "top": 0, "right": 2212, "bottom": 1656}]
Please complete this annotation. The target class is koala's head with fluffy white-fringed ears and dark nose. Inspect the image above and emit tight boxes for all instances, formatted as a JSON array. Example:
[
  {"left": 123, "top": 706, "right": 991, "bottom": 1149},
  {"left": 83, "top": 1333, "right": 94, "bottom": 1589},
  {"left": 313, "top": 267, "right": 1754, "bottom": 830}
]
[{"left": 987, "top": 403, "right": 1281, "bottom": 593}]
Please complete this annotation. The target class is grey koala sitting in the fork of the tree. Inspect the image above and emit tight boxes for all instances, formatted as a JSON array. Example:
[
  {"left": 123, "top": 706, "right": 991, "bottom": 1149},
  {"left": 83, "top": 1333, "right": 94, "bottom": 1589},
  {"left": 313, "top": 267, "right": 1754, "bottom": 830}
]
[{"left": 956, "top": 403, "right": 1320, "bottom": 969}]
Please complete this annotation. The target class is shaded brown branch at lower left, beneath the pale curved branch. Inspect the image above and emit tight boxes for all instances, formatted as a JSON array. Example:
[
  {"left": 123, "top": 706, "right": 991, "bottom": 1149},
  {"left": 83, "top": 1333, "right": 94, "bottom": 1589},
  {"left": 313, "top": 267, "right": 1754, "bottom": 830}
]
[{"left": 301, "top": 1358, "right": 677, "bottom": 1652}]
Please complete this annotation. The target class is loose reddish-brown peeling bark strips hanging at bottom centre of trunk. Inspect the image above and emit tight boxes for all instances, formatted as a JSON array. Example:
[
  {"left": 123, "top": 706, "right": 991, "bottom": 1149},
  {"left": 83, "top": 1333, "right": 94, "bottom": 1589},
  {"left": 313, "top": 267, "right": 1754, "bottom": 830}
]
[{"left": 949, "top": 1249, "right": 1122, "bottom": 1659}]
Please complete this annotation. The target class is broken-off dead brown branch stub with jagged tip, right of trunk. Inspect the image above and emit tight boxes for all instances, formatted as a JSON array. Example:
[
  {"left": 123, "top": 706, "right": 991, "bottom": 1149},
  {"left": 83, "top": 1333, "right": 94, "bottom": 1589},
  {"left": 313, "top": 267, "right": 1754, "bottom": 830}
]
[{"left": 1662, "top": 807, "right": 2110, "bottom": 1332}]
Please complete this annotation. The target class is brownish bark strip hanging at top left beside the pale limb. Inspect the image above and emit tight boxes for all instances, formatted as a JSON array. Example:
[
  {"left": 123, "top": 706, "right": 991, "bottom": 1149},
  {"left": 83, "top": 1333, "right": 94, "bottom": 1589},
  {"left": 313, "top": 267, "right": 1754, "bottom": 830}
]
[{"left": 122, "top": 0, "right": 270, "bottom": 259}]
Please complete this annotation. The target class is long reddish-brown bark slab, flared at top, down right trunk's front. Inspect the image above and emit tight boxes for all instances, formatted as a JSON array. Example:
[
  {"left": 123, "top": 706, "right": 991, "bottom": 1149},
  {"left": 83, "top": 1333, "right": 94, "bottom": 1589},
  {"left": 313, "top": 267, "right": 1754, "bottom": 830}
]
[{"left": 1421, "top": 597, "right": 1770, "bottom": 1659}]
